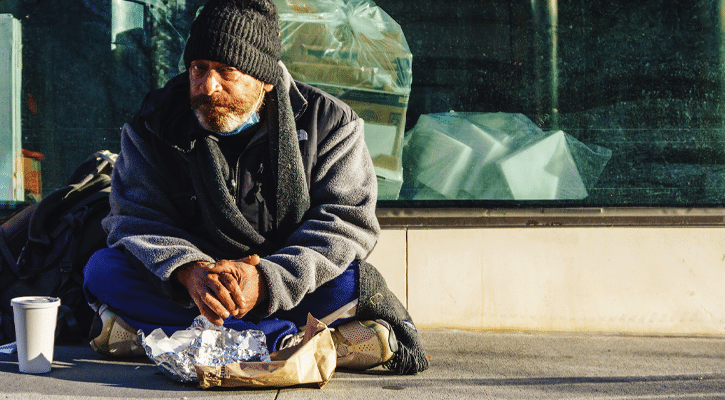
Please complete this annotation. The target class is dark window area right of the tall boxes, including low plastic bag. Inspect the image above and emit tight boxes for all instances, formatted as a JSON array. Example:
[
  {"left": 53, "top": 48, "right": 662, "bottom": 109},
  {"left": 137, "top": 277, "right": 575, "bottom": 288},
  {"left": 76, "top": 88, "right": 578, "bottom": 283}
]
[{"left": 388, "top": 0, "right": 725, "bottom": 206}]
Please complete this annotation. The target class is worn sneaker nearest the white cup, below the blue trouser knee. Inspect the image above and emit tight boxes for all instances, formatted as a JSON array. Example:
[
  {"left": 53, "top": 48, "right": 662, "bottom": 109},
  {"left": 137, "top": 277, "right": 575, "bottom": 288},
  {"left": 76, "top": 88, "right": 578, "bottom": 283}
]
[{"left": 89, "top": 304, "right": 146, "bottom": 357}]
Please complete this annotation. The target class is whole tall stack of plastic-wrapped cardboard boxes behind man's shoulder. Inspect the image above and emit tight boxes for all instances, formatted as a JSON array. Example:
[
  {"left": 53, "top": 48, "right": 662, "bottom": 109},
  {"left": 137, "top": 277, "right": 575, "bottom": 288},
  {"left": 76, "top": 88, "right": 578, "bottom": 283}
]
[{"left": 275, "top": 0, "right": 412, "bottom": 200}]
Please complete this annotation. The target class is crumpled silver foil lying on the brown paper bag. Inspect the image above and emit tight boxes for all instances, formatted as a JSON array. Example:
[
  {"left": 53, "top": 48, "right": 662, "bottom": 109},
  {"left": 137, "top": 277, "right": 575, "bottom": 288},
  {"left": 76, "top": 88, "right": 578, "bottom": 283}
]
[{"left": 138, "top": 315, "right": 271, "bottom": 382}]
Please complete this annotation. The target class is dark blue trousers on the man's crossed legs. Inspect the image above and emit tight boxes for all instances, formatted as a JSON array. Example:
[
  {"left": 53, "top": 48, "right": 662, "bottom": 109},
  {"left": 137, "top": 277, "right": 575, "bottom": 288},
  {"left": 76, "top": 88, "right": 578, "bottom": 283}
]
[{"left": 83, "top": 249, "right": 359, "bottom": 351}]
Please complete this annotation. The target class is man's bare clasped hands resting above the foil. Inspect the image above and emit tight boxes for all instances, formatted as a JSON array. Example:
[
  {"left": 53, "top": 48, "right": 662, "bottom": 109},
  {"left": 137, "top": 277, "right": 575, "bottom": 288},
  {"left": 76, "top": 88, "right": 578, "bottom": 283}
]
[{"left": 176, "top": 255, "right": 267, "bottom": 325}]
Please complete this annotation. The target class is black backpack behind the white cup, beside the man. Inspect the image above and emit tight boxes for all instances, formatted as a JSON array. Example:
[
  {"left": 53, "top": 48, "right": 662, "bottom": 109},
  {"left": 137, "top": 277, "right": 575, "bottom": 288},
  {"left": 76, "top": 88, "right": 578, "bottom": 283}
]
[{"left": 0, "top": 150, "right": 116, "bottom": 344}]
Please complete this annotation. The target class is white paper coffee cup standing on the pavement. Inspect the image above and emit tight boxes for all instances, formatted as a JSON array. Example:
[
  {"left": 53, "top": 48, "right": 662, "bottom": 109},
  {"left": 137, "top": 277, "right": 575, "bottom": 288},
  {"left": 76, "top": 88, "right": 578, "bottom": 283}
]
[{"left": 10, "top": 296, "right": 60, "bottom": 374}]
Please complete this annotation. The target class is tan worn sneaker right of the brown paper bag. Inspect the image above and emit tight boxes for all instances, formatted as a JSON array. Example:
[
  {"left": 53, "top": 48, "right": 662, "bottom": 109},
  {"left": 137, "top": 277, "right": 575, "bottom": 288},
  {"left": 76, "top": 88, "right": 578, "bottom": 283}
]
[{"left": 332, "top": 319, "right": 398, "bottom": 370}]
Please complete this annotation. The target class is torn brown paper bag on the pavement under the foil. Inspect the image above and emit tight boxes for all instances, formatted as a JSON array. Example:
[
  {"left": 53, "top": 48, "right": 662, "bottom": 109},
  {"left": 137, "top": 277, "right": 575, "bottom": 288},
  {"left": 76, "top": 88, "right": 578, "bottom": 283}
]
[{"left": 195, "top": 315, "right": 337, "bottom": 389}]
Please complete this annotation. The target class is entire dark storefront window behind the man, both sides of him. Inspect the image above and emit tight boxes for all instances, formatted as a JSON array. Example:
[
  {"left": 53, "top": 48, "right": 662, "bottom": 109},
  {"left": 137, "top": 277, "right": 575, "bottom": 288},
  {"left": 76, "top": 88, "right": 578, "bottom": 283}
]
[{"left": 0, "top": 0, "right": 725, "bottom": 207}]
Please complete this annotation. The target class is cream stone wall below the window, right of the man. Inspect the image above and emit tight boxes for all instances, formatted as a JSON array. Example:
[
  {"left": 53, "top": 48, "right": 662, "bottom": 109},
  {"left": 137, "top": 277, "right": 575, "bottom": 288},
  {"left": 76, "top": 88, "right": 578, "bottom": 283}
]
[{"left": 369, "top": 227, "right": 725, "bottom": 335}]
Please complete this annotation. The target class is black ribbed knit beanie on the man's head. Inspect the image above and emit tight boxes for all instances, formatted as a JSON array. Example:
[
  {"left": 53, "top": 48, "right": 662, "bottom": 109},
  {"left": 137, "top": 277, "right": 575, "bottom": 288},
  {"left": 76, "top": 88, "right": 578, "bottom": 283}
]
[{"left": 184, "top": 0, "right": 282, "bottom": 84}]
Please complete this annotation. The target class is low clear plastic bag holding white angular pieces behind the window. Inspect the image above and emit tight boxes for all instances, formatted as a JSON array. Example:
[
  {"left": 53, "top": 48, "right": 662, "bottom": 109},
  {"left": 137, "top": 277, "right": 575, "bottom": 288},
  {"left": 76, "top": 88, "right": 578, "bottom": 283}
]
[{"left": 403, "top": 112, "right": 612, "bottom": 200}]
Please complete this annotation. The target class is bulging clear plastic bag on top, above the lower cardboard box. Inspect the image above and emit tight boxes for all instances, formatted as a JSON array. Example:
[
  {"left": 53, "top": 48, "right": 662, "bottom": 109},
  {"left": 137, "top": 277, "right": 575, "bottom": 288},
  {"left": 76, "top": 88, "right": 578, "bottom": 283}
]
[{"left": 275, "top": 0, "right": 412, "bottom": 94}]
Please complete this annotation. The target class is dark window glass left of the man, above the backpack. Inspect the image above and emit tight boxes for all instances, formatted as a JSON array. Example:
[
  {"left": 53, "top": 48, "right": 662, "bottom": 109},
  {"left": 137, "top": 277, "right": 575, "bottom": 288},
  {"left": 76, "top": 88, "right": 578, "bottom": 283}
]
[{"left": 0, "top": 0, "right": 202, "bottom": 202}]
